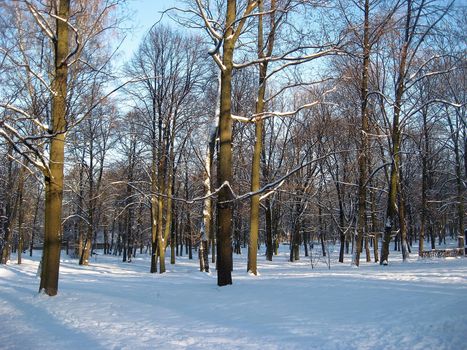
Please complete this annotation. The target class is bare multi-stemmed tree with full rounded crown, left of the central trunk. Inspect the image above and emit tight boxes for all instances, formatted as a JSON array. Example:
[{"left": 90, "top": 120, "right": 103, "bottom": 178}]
[{"left": 127, "top": 25, "right": 206, "bottom": 273}]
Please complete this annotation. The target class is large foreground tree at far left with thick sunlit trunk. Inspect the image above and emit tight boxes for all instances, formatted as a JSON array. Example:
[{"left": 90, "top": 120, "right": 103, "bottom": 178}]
[{"left": 0, "top": 0, "right": 126, "bottom": 296}]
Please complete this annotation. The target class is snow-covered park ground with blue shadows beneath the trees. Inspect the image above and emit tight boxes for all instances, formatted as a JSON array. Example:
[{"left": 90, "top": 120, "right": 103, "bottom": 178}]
[{"left": 0, "top": 243, "right": 467, "bottom": 350}]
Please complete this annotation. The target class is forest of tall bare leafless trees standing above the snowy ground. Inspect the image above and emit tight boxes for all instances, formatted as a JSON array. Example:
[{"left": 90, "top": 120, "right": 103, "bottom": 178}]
[{"left": 0, "top": 0, "right": 467, "bottom": 296}]
